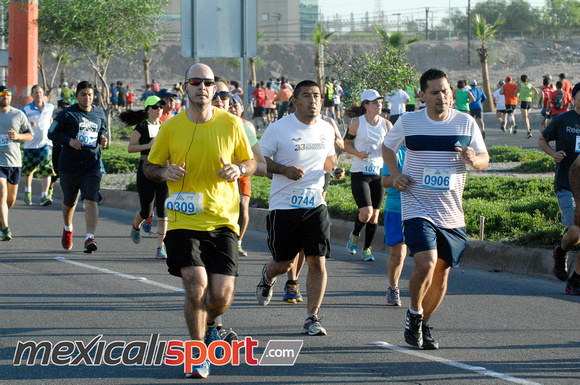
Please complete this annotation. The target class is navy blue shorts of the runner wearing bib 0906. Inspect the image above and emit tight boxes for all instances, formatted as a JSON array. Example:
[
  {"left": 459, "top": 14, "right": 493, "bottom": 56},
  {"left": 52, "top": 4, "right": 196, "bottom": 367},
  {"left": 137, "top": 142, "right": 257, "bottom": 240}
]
[{"left": 403, "top": 218, "right": 467, "bottom": 267}]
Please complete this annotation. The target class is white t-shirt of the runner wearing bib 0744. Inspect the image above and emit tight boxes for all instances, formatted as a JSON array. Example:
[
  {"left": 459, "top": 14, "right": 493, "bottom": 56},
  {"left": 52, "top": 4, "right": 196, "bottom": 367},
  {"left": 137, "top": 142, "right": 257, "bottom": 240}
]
[{"left": 260, "top": 114, "right": 335, "bottom": 211}]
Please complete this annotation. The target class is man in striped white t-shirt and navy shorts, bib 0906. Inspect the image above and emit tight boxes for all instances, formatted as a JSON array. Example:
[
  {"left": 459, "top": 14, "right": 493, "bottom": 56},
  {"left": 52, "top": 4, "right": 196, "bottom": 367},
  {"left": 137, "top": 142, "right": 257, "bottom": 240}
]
[{"left": 382, "top": 69, "right": 489, "bottom": 349}]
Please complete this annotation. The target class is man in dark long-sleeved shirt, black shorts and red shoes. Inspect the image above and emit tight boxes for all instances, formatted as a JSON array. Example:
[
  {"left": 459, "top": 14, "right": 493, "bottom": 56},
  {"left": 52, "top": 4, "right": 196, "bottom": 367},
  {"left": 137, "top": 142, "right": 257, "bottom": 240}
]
[{"left": 48, "top": 81, "right": 107, "bottom": 253}]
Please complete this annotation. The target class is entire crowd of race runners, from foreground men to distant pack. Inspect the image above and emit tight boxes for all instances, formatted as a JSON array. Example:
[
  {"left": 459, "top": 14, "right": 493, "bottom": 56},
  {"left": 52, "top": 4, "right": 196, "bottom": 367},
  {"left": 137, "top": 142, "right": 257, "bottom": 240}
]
[{"left": 0, "top": 64, "right": 580, "bottom": 378}]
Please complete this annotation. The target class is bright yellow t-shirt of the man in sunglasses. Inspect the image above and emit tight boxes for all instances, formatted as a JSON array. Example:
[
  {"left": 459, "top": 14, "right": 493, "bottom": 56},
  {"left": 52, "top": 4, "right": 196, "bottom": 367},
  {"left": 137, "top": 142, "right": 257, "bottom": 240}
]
[{"left": 148, "top": 107, "right": 253, "bottom": 234}]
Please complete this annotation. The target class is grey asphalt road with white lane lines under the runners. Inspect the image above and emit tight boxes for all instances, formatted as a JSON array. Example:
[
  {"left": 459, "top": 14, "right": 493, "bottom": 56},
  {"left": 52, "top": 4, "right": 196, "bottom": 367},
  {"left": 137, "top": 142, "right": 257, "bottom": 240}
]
[{"left": 0, "top": 197, "right": 580, "bottom": 385}]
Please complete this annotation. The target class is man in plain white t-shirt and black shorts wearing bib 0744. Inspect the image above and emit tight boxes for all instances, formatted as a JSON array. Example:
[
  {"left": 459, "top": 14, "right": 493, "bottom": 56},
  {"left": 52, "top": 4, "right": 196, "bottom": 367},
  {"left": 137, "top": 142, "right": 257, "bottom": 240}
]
[{"left": 256, "top": 80, "right": 344, "bottom": 335}]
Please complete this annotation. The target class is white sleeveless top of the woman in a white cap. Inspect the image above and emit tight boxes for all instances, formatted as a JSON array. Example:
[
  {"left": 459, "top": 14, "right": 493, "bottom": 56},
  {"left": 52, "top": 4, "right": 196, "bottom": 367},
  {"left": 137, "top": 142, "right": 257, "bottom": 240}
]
[{"left": 350, "top": 115, "right": 387, "bottom": 175}]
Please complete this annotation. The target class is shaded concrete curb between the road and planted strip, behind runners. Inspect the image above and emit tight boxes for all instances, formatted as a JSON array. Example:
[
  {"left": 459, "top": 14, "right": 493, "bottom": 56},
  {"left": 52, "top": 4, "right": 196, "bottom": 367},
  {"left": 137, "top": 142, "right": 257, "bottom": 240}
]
[{"left": 18, "top": 179, "right": 556, "bottom": 279}]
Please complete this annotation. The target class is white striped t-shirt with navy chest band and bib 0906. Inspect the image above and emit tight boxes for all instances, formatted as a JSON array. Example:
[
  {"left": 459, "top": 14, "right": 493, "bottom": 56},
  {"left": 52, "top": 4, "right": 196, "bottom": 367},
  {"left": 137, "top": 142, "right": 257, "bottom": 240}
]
[{"left": 384, "top": 109, "right": 487, "bottom": 229}]
